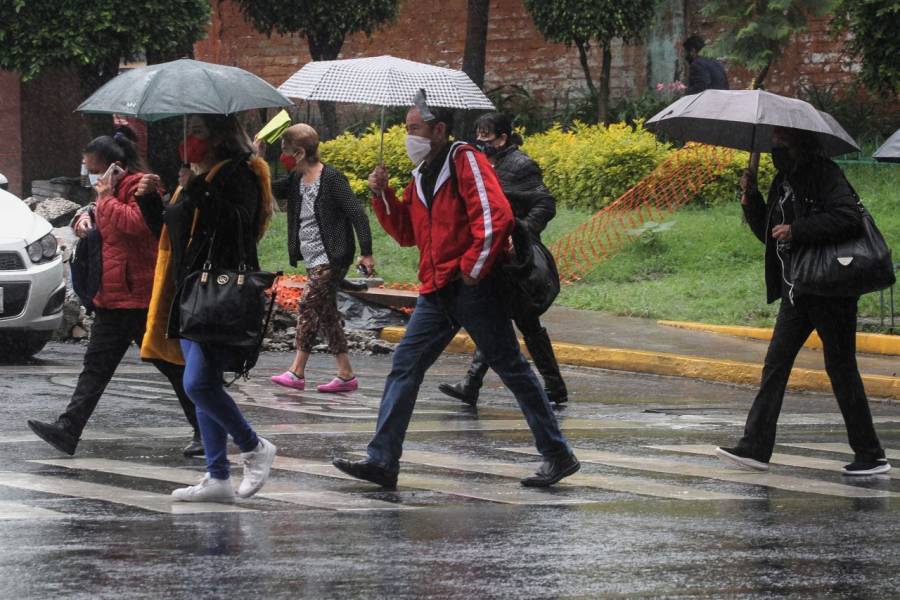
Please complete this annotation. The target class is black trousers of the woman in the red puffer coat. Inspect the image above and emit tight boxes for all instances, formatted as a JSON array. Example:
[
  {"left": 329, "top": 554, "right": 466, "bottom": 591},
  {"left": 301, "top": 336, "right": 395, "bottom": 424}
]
[{"left": 59, "top": 308, "right": 197, "bottom": 437}]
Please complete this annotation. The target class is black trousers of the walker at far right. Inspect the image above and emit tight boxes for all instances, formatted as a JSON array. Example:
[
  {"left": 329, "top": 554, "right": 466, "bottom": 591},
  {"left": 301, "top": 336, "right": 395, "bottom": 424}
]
[{"left": 738, "top": 296, "right": 884, "bottom": 462}]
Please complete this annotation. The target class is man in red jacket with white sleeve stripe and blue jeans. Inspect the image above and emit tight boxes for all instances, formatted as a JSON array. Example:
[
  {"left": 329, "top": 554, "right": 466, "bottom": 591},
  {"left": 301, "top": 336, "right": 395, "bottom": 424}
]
[{"left": 334, "top": 98, "right": 580, "bottom": 488}]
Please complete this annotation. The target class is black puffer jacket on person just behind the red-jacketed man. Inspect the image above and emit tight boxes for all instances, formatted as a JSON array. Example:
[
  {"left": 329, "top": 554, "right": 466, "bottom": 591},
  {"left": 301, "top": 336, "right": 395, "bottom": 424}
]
[{"left": 491, "top": 144, "right": 556, "bottom": 235}]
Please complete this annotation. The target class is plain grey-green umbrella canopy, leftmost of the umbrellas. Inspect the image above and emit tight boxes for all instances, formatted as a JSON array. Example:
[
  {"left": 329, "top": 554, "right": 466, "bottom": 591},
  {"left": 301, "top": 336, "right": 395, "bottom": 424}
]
[{"left": 75, "top": 59, "right": 291, "bottom": 121}]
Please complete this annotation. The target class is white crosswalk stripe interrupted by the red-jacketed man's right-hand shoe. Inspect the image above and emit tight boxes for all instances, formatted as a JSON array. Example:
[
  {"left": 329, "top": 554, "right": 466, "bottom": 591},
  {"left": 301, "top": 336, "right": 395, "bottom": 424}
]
[{"left": 402, "top": 450, "right": 751, "bottom": 500}]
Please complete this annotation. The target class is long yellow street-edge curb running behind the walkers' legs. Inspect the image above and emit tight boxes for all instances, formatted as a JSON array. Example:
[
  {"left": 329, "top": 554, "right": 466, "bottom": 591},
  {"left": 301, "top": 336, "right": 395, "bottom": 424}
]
[{"left": 380, "top": 327, "right": 900, "bottom": 400}]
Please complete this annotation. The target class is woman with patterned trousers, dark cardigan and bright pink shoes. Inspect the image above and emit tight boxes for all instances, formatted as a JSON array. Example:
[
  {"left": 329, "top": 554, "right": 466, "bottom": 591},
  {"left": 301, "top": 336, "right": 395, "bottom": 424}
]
[{"left": 272, "top": 123, "right": 375, "bottom": 392}]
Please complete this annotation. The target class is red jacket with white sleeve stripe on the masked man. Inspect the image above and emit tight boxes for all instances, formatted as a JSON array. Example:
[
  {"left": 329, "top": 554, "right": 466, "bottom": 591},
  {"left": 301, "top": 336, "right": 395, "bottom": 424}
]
[{"left": 372, "top": 142, "right": 515, "bottom": 294}]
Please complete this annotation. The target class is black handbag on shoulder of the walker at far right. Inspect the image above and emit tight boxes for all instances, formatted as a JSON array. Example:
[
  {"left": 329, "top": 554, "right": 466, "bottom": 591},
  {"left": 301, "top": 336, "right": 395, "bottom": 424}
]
[{"left": 791, "top": 182, "right": 896, "bottom": 296}]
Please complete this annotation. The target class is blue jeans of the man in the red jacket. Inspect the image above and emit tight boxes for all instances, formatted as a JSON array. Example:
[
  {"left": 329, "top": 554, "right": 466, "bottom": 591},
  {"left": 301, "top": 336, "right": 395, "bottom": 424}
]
[{"left": 368, "top": 278, "right": 572, "bottom": 472}]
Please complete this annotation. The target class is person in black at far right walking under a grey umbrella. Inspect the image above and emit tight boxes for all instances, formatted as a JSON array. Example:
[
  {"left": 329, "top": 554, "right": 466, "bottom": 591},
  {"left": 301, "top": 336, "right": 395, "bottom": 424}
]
[{"left": 716, "top": 127, "right": 891, "bottom": 475}]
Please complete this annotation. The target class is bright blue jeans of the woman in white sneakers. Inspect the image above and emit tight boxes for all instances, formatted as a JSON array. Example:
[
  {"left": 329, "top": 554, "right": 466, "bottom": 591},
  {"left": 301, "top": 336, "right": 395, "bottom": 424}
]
[{"left": 181, "top": 339, "right": 259, "bottom": 479}]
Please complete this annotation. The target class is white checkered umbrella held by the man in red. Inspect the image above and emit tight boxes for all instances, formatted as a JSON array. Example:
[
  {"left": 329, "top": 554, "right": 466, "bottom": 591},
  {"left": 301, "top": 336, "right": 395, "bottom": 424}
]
[{"left": 278, "top": 56, "right": 494, "bottom": 110}]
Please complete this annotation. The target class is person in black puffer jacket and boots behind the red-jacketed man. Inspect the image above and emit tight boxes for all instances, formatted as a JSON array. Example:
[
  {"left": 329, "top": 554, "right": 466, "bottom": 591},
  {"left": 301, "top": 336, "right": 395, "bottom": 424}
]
[{"left": 438, "top": 113, "right": 568, "bottom": 406}]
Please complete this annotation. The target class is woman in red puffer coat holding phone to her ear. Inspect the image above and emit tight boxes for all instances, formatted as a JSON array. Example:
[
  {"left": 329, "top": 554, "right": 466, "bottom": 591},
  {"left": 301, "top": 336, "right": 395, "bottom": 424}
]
[{"left": 28, "top": 131, "right": 203, "bottom": 456}]
